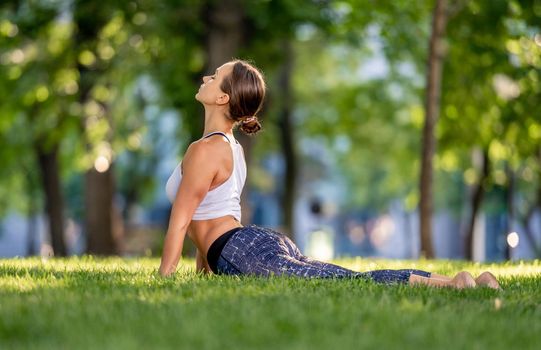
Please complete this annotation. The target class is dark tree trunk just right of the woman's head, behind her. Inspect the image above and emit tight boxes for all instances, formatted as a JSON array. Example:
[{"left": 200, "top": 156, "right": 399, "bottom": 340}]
[{"left": 278, "top": 39, "right": 297, "bottom": 238}]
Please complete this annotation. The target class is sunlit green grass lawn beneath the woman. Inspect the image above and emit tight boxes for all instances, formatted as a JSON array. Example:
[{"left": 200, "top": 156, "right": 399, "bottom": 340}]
[{"left": 0, "top": 256, "right": 541, "bottom": 349}]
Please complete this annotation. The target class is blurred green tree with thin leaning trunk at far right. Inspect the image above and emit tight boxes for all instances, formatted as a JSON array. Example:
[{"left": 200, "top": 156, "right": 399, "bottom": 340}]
[{"left": 438, "top": 1, "right": 539, "bottom": 259}]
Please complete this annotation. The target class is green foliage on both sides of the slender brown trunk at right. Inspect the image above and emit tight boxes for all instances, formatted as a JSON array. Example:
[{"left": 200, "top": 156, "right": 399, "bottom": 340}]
[{"left": 295, "top": 1, "right": 541, "bottom": 219}]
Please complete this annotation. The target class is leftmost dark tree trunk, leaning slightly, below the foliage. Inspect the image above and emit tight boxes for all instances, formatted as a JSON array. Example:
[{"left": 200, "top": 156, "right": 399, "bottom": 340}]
[{"left": 35, "top": 141, "right": 67, "bottom": 256}]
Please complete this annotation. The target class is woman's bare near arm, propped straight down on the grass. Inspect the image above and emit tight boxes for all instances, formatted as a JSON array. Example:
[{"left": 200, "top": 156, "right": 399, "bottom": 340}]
[{"left": 159, "top": 142, "right": 218, "bottom": 276}]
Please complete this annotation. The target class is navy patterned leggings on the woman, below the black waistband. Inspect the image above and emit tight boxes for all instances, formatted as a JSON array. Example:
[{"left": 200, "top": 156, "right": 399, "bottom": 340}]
[{"left": 217, "top": 225, "right": 430, "bottom": 283}]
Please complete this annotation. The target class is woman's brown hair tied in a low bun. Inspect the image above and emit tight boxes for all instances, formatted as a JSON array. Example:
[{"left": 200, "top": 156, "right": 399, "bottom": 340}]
[{"left": 220, "top": 60, "right": 266, "bottom": 134}]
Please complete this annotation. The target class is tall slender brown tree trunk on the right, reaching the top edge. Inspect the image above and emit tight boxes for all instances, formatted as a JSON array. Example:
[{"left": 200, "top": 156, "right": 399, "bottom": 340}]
[{"left": 420, "top": 0, "right": 447, "bottom": 258}]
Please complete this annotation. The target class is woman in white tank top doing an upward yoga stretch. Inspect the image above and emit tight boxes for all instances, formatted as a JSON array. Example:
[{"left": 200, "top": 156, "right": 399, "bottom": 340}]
[{"left": 159, "top": 60, "right": 499, "bottom": 288}]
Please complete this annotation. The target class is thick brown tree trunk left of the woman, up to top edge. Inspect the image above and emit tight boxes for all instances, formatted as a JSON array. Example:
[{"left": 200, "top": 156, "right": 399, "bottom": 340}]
[{"left": 73, "top": 1, "right": 123, "bottom": 255}]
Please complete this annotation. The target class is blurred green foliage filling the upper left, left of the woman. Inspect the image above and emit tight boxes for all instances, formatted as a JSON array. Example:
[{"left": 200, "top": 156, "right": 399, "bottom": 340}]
[{"left": 0, "top": 1, "right": 184, "bottom": 219}]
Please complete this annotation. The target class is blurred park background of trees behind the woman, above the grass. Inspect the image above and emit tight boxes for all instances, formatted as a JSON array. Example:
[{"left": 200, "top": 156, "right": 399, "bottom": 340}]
[{"left": 0, "top": 0, "right": 541, "bottom": 261}]
